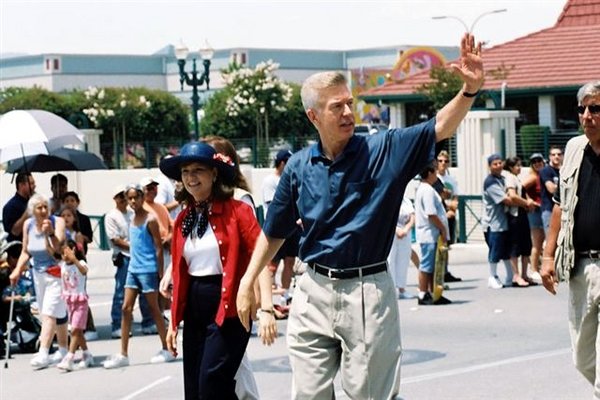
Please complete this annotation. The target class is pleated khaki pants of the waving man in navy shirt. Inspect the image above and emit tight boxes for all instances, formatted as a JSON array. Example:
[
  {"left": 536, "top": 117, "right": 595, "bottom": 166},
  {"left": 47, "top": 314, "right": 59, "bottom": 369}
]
[{"left": 287, "top": 268, "right": 402, "bottom": 400}]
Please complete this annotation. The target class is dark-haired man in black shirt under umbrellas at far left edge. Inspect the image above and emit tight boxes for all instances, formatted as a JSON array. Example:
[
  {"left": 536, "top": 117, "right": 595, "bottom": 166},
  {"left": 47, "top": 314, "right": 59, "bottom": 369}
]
[{"left": 2, "top": 172, "right": 35, "bottom": 242}]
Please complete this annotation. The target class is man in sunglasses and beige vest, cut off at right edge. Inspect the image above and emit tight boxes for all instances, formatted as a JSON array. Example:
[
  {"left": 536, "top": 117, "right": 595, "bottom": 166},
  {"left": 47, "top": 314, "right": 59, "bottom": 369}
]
[{"left": 542, "top": 80, "right": 600, "bottom": 399}]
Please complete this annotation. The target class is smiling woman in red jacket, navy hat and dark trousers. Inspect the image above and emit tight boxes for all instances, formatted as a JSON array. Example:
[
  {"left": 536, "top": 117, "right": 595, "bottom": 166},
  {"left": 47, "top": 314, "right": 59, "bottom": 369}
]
[{"left": 160, "top": 142, "right": 260, "bottom": 399}]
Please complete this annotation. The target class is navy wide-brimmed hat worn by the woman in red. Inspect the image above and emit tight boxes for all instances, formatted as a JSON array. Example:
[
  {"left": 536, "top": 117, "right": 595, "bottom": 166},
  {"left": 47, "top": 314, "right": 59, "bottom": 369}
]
[{"left": 158, "top": 142, "right": 235, "bottom": 184}]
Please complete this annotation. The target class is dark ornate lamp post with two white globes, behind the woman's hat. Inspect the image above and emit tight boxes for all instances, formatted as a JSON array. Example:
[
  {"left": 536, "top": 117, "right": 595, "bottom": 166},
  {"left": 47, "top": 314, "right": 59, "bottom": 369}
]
[{"left": 175, "top": 42, "right": 215, "bottom": 140}]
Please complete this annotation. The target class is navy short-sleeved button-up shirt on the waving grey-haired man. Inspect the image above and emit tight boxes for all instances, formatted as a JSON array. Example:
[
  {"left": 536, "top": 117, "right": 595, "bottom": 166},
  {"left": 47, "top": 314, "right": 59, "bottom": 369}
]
[{"left": 263, "top": 119, "right": 435, "bottom": 269}]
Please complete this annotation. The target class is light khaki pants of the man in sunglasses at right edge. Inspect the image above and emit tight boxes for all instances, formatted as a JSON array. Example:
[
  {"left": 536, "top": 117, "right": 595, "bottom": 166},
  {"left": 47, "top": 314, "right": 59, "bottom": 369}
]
[{"left": 569, "top": 258, "right": 600, "bottom": 399}]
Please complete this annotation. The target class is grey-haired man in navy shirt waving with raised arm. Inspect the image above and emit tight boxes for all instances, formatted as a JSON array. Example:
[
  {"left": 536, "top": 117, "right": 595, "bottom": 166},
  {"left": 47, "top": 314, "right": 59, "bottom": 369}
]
[{"left": 237, "top": 34, "right": 484, "bottom": 400}]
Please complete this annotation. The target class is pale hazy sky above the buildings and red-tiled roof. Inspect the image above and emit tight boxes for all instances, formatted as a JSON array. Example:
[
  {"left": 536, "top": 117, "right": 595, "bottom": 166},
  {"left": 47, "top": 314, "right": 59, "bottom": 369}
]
[{"left": 0, "top": 0, "right": 566, "bottom": 54}]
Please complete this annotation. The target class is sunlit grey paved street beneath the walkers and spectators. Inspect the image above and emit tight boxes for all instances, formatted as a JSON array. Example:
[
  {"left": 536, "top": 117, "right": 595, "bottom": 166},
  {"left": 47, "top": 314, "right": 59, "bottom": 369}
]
[{"left": 0, "top": 248, "right": 592, "bottom": 400}]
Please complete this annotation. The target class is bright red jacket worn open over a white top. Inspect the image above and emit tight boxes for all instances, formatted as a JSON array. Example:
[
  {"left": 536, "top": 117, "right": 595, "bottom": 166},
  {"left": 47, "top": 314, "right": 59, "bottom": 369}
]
[{"left": 171, "top": 199, "right": 260, "bottom": 328}]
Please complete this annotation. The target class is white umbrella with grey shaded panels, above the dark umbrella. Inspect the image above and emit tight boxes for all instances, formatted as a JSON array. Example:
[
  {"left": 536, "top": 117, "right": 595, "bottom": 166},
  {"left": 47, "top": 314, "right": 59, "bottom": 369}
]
[{"left": 0, "top": 110, "right": 83, "bottom": 163}]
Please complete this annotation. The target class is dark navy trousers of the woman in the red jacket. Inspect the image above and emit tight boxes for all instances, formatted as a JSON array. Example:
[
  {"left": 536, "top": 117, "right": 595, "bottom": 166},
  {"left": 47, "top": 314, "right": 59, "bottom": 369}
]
[{"left": 183, "top": 275, "right": 250, "bottom": 400}]
